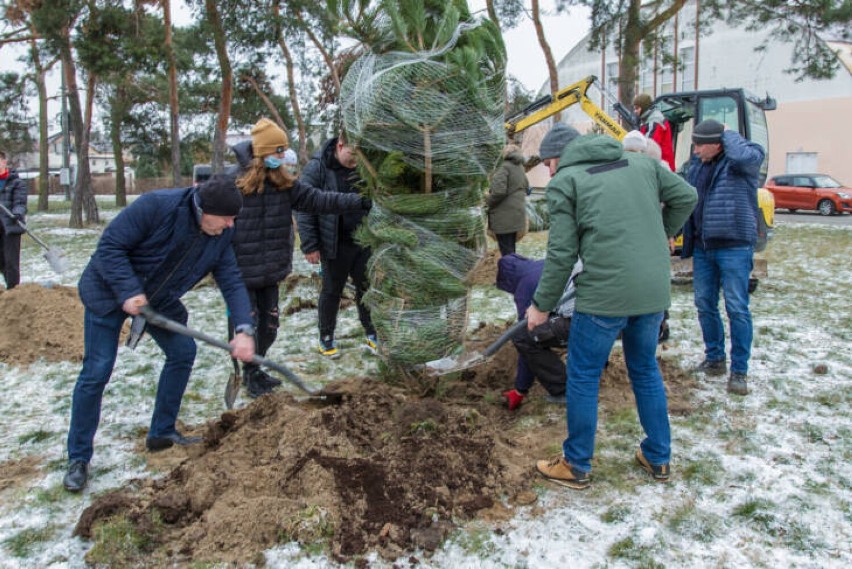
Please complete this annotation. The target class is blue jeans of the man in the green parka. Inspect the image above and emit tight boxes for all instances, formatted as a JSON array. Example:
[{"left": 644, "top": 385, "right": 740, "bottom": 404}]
[{"left": 562, "top": 312, "right": 671, "bottom": 472}]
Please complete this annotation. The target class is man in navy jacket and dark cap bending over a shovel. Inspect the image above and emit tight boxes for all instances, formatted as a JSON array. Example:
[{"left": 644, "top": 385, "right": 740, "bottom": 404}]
[{"left": 63, "top": 176, "right": 254, "bottom": 492}]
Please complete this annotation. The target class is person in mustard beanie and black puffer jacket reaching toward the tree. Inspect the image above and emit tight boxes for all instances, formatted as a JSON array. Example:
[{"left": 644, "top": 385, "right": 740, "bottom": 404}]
[{"left": 232, "top": 118, "right": 371, "bottom": 397}]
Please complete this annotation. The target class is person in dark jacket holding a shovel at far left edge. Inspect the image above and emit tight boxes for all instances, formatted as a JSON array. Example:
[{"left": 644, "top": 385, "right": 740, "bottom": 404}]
[{"left": 0, "top": 152, "right": 27, "bottom": 290}]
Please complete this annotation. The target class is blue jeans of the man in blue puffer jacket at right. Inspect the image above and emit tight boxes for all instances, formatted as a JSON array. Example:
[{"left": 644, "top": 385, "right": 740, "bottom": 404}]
[{"left": 692, "top": 246, "right": 754, "bottom": 373}]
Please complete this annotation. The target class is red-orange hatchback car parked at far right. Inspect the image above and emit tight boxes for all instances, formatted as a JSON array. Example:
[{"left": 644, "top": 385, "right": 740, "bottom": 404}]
[{"left": 766, "top": 174, "right": 852, "bottom": 215}]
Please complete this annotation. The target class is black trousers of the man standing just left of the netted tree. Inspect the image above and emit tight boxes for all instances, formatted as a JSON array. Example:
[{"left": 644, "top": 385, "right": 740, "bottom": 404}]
[{"left": 318, "top": 240, "right": 376, "bottom": 338}]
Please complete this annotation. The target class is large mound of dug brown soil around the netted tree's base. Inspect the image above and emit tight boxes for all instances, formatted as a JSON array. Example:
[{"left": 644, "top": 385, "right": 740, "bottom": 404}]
[{"left": 75, "top": 320, "right": 694, "bottom": 565}]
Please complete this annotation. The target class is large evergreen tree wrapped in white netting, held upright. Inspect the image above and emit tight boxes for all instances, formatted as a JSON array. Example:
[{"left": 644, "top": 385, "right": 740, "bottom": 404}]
[{"left": 340, "top": 0, "right": 506, "bottom": 369}]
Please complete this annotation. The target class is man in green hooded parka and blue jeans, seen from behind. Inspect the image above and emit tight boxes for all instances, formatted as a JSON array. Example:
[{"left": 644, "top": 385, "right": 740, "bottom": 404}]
[{"left": 527, "top": 124, "right": 698, "bottom": 489}]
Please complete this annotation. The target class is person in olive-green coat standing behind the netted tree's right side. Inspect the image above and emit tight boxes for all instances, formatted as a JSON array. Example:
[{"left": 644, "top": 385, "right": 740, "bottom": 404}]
[{"left": 488, "top": 144, "right": 530, "bottom": 256}]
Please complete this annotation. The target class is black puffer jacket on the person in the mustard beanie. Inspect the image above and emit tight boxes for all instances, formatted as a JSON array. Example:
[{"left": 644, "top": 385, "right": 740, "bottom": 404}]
[{"left": 232, "top": 140, "right": 362, "bottom": 289}]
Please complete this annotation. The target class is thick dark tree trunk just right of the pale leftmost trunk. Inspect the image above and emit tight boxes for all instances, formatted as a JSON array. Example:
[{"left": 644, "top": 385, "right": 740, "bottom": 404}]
[{"left": 60, "top": 36, "right": 98, "bottom": 228}]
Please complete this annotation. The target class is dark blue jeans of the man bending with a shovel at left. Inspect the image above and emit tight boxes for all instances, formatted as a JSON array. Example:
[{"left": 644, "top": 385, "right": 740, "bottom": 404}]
[{"left": 68, "top": 309, "right": 196, "bottom": 463}]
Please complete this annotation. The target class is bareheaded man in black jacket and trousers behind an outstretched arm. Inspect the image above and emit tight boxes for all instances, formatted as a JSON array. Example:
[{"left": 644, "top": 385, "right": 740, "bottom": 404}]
[{"left": 296, "top": 133, "right": 378, "bottom": 358}]
